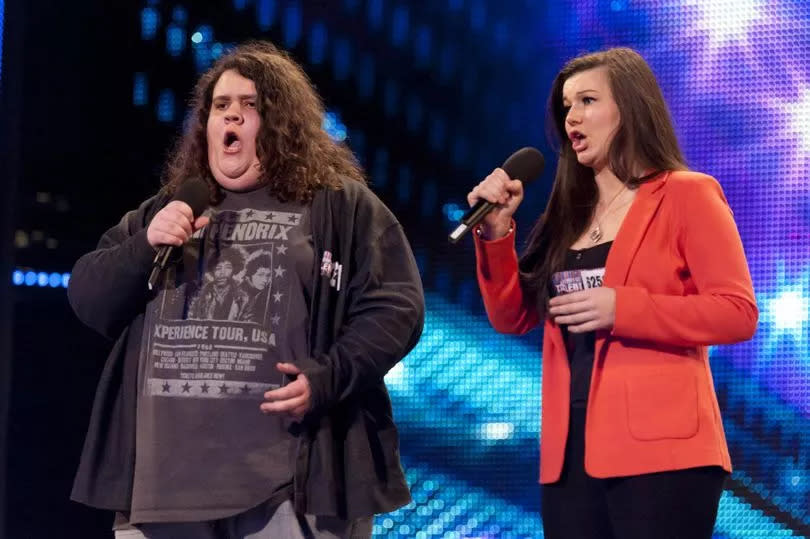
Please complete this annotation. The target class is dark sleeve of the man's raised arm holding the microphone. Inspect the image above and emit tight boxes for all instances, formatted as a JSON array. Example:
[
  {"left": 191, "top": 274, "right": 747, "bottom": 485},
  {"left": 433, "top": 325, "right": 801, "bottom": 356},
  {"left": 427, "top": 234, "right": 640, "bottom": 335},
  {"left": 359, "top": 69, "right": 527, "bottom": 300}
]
[{"left": 68, "top": 197, "right": 163, "bottom": 339}]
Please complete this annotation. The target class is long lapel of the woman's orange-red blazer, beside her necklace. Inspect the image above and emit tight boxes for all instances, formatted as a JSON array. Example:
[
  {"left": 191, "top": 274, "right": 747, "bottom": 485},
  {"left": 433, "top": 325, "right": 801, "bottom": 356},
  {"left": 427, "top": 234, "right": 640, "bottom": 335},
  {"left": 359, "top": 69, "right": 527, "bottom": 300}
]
[{"left": 604, "top": 172, "right": 669, "bottom": 286}]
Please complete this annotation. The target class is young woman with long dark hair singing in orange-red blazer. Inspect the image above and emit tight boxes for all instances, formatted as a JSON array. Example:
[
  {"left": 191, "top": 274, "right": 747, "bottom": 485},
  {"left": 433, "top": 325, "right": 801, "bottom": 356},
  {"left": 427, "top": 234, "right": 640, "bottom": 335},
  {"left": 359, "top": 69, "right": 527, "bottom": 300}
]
[{"left": 468, "top": 48, "right": 758, "bottom": 539}]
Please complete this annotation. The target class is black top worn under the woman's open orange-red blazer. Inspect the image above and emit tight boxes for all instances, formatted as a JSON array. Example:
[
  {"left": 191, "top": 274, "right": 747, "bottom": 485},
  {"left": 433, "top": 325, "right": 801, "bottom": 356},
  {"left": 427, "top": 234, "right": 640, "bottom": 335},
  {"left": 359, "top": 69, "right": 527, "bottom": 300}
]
[{"left": 551, "top": 241, "right": 613, "bottom": 408}]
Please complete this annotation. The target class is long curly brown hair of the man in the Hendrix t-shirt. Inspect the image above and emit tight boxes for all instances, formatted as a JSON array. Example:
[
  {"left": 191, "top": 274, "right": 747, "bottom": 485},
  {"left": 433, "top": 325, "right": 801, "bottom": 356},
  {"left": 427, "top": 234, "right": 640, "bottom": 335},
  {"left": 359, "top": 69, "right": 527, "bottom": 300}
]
[{"left": 163, "top": 41, "right": 366, "bottom": 204}]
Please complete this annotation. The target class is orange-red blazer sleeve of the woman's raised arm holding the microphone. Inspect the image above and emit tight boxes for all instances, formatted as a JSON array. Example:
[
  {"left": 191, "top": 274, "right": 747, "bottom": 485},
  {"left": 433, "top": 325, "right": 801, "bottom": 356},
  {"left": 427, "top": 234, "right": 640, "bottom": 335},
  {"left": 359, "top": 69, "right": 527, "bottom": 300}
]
[{"left": 473, "top": 223, "right": 539, "bottom": 335}]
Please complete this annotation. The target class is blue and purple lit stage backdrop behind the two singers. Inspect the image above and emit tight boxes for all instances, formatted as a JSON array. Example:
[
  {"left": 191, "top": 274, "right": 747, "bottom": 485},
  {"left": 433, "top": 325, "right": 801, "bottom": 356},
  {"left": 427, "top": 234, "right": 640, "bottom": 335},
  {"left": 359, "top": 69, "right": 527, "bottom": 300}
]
[{"left": 15, "top": 0, "right": 810, "bottom": 539}]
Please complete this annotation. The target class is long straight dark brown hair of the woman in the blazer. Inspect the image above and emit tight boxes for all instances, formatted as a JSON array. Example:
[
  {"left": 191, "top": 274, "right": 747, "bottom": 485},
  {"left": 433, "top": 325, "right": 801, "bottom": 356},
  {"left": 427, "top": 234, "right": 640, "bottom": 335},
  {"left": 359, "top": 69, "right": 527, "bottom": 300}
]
[{"left": 520, "top": 48, "right": 687, "bottom": 317}]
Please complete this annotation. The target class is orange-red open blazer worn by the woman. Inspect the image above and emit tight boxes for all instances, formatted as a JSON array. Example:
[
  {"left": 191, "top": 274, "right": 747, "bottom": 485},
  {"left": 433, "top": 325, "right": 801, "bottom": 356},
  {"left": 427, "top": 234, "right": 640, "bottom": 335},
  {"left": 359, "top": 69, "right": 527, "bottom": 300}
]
[{"left": 475, "top": 172, "right": 759, "bottom": 483}]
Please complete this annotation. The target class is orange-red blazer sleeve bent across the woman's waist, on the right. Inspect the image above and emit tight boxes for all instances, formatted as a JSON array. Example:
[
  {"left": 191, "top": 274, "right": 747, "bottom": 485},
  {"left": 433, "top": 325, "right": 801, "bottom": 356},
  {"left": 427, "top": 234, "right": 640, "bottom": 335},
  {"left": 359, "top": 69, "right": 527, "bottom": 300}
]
[{"left": 612, "top": 176, "right": 759, "bottom": 346}]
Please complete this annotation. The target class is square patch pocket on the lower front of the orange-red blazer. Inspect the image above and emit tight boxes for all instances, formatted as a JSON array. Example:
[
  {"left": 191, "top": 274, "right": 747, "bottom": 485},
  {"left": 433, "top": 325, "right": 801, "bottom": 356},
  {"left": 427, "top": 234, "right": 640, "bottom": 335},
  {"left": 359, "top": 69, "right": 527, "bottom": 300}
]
[{"left": 625, "top": 372, "right": 699, "bottom": 441}]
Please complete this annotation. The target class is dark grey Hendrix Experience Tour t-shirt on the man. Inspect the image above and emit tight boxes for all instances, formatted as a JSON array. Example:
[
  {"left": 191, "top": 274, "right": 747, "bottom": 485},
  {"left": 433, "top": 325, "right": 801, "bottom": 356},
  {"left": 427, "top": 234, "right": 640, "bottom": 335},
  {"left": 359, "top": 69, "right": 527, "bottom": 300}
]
[{"left": 129, "top": 188, "right": 315, "bottom": 523}]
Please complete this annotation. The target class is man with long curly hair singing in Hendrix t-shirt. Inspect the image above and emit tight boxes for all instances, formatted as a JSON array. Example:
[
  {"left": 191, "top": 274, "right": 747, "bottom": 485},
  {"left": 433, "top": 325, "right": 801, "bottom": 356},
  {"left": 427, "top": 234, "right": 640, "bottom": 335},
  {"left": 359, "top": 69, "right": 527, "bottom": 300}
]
[{"left": 68, "top": 42, "right": 424, "bottom": 538}]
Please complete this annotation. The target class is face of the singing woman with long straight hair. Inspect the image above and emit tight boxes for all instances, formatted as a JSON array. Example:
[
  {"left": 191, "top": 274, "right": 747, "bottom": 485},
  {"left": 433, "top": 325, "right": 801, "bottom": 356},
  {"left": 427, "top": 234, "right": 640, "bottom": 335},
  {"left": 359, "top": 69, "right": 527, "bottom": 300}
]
[{"left": 562, "top": 67, "right": 621, "bottom": 173}]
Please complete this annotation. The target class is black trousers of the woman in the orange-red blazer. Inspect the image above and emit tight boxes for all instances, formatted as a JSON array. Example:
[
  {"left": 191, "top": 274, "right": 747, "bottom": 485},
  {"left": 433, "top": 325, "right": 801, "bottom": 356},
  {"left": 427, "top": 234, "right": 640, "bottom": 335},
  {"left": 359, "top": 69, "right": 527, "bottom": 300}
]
[{"left": 541, "top": 407, "right": 727, "bottom": 539}]
